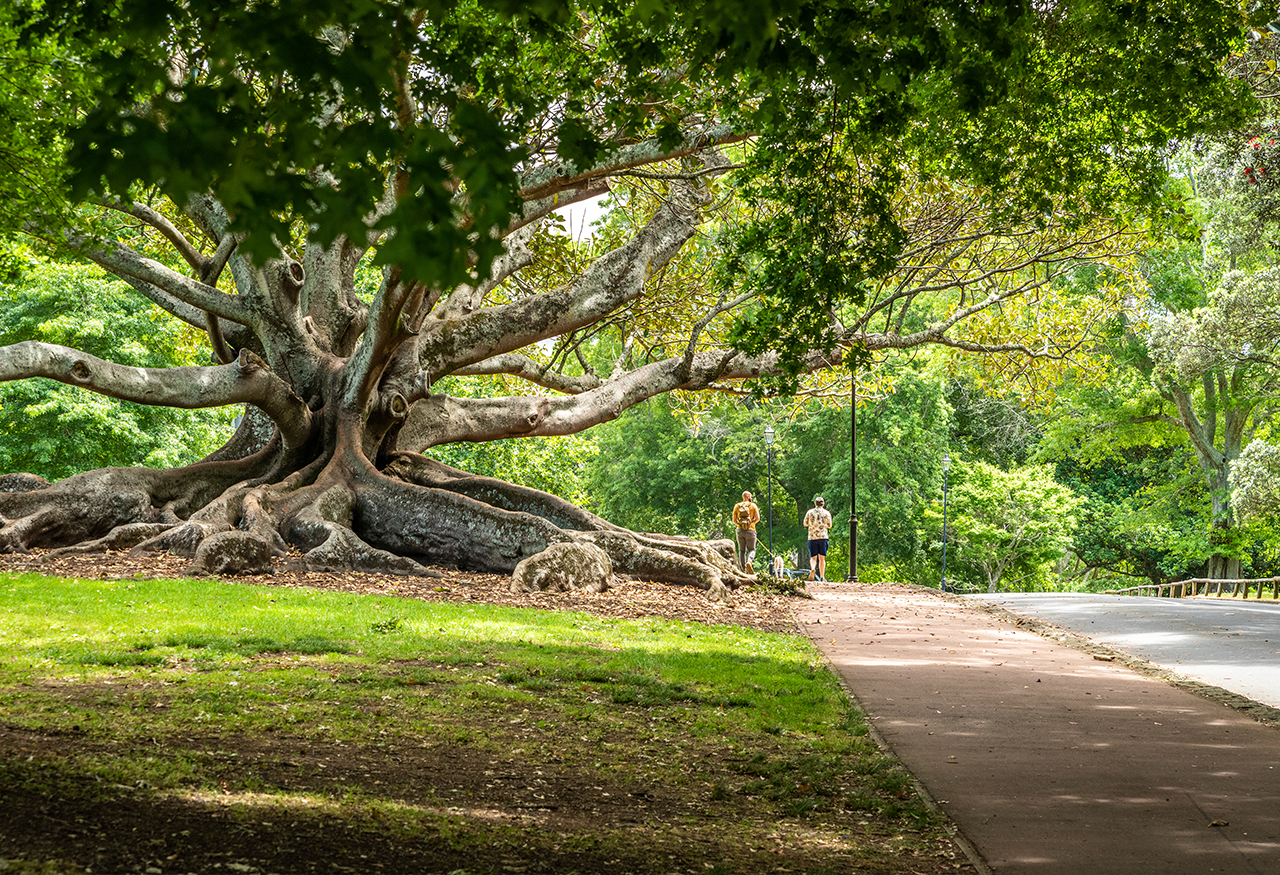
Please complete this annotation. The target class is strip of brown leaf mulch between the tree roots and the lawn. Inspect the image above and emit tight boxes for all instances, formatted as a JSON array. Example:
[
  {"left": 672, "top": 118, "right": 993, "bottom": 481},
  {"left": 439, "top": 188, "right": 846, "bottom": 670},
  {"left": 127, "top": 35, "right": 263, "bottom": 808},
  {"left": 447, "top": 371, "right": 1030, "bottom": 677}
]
[{"left": 0, "top": 553, "right": 797, "bottom": 633}]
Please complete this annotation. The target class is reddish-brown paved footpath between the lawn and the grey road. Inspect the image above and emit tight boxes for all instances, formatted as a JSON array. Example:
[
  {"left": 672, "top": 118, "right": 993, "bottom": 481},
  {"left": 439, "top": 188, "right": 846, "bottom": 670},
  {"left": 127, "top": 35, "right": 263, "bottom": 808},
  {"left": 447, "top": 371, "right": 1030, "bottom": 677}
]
[{"left": 797, "top": 583, "right": 1280, "bottom": 875}]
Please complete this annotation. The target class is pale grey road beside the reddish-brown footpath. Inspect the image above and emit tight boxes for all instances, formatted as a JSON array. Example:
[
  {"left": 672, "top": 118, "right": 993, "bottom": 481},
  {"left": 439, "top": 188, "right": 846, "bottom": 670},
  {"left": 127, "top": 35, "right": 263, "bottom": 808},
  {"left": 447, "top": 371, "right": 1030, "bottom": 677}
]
[{"left": 968, "top": 592, "right": 1280, "bottom": 707}]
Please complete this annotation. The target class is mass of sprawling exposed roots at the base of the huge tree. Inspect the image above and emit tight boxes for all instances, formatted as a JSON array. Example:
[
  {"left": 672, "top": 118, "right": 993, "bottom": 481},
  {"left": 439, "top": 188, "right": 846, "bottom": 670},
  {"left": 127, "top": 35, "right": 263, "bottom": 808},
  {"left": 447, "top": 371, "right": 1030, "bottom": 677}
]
[{"left": 0, "top": 453, "right": 754, "bottom": 601}]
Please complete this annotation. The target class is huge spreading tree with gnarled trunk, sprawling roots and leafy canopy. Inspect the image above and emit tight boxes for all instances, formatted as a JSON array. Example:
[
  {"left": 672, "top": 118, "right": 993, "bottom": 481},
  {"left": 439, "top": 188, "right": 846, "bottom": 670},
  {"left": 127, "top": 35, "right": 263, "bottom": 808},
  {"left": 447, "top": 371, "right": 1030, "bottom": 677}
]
[{"left": 0, "top": 0, "right": 1244, "bottom": 591}]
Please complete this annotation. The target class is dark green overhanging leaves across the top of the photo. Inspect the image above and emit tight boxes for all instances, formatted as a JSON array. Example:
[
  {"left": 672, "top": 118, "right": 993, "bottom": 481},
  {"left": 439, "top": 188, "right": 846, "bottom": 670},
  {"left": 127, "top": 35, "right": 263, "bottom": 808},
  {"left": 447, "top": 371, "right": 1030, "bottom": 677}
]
[{"left": 13, "top": 0, "right": 1248, "bottom": 304}]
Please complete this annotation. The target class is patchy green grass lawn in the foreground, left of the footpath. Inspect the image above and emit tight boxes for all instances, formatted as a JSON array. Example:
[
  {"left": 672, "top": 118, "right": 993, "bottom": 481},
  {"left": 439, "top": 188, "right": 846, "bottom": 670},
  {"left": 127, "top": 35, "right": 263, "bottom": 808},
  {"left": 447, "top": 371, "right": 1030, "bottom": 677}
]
[{"left": 0, "top": 576, "right": 959, "bottom": 872}]
